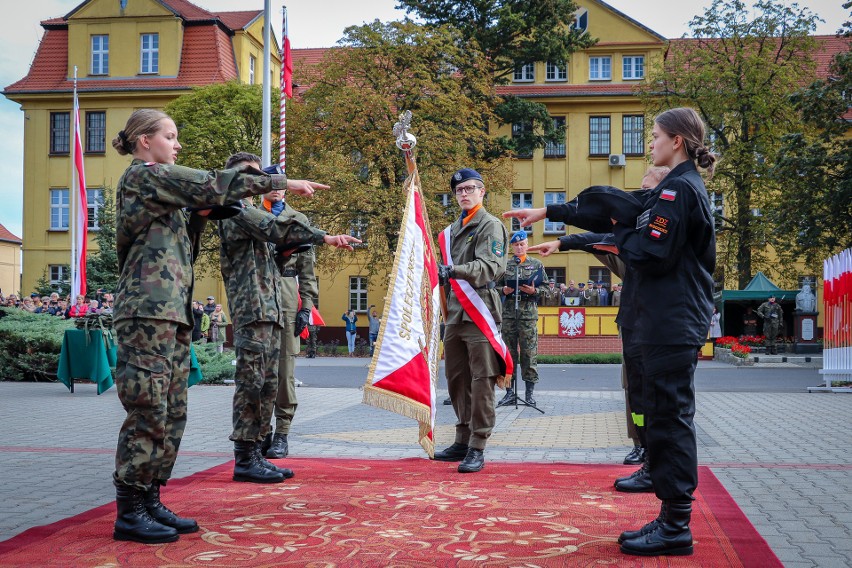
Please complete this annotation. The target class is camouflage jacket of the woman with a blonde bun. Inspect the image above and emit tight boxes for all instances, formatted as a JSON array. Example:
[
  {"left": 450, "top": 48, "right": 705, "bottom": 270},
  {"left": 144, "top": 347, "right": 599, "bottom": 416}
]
[{"left": 113, "top": 159, "right": 287, "bottom": 326}]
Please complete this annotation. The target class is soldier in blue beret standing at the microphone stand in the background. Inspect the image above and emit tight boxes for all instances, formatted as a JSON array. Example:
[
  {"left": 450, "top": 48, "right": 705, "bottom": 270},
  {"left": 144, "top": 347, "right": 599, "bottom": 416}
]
[{"left": 498, "top": 229, "right": 548, "bottom": 406}]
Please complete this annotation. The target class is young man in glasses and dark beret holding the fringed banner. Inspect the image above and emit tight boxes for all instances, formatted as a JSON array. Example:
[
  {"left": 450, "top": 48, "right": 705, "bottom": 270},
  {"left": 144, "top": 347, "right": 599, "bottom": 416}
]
[{"left": 435, "top": 168, "right": 509, "bottom": 473}]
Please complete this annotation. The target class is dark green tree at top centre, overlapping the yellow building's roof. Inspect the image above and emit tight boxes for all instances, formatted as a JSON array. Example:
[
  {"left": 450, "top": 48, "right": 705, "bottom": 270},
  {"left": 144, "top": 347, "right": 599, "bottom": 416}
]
[{"left": 399, "top": 0, "right": 597, "bottom": 156}]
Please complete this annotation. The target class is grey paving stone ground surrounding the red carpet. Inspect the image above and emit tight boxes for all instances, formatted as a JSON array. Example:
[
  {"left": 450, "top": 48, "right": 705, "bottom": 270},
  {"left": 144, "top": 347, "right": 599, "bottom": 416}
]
[{"left": 0, "top": 372, "right": 852, "bottom": 568}]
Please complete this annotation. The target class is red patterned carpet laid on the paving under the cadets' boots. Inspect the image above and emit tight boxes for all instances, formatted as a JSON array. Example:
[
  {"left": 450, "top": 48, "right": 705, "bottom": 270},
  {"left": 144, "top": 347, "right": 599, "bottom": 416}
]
[{"left": 0, "top": 459, "right": 781, "bottom": 568}]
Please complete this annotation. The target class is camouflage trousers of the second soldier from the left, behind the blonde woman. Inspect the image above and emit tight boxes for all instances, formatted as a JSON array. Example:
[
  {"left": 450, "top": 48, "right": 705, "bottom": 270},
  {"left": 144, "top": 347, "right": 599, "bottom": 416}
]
[{"left": 230, "top": 322, "right": 281, "bottom": 442}]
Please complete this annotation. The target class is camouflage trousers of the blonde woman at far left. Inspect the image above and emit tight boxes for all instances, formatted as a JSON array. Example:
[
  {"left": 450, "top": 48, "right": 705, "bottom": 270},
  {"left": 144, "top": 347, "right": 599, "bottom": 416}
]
[{"left": 113, "top": 318, "right": 192, "bottom": 489}]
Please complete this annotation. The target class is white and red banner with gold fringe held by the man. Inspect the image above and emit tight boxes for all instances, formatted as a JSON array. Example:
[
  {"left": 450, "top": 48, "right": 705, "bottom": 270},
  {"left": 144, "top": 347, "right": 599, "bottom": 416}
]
[{"left": 364, "top": 171, "right": 440, "bottom": 458}]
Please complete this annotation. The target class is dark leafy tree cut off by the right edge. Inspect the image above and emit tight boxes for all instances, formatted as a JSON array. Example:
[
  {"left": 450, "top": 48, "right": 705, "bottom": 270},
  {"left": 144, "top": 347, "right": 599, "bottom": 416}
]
[{"left": 772, "top": 2, "right": 852, "bottom": 262}]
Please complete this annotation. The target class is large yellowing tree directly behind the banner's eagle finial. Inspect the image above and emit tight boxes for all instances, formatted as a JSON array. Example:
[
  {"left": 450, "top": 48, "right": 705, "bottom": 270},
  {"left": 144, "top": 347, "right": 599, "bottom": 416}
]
[{"left": 287, "top": 21, "right": 512, "bottom": 273}]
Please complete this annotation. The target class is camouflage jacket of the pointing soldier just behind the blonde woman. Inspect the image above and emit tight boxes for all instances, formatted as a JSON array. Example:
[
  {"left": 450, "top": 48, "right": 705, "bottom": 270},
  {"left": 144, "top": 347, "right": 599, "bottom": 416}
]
[{"left": 218, "top": 204, "right": 326, "bottom": 330}]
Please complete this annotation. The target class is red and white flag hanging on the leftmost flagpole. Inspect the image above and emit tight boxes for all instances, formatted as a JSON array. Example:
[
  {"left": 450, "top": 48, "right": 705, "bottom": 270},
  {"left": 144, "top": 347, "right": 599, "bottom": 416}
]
[{"left": 69, "top": 80, "right": 89, "bottom": 305}]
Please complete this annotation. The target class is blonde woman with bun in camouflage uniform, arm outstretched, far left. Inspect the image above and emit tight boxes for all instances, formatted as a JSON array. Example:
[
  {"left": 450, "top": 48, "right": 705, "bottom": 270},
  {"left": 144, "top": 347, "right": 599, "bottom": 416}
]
[{"left": 112, "top": 109, "right": 326, "bottom": 543}]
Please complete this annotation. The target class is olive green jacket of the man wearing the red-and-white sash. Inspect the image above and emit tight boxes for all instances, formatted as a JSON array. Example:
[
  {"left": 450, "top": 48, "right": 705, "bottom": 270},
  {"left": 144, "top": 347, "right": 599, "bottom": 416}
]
[{"left": 446, "top": 207, "right": 509, "bottom": 325}]
